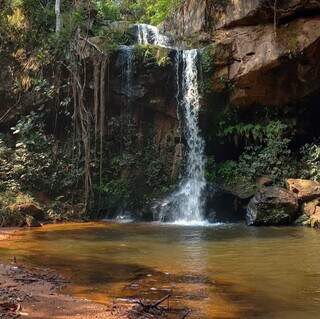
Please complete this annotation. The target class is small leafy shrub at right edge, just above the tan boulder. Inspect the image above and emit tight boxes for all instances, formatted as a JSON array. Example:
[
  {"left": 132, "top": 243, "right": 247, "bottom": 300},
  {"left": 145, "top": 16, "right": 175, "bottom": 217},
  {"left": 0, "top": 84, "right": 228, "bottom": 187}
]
[{"left": 301, "top": 142, "right": 320, "bottom": 182}]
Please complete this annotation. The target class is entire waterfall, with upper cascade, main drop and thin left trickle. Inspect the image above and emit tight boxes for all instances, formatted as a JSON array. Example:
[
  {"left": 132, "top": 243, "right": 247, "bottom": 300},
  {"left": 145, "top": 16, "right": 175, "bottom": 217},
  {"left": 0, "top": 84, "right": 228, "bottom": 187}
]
[{"left": 115, "top": 24, "right": 206, "bottom": 225}]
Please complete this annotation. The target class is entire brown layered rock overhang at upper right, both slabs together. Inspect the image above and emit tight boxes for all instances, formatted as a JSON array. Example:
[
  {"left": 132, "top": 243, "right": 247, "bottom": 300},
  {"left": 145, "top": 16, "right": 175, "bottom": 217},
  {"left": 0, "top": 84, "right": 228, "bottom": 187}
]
[{"left": 164, "top": 0, "right": 320, "bottom": 106}]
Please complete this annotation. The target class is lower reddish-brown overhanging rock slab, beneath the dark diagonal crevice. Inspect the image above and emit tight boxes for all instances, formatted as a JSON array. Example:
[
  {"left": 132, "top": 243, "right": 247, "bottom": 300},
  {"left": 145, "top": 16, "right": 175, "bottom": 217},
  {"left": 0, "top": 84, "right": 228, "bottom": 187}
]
[{"left": 213, "top": 17, "right": 320, "bottom": 106}]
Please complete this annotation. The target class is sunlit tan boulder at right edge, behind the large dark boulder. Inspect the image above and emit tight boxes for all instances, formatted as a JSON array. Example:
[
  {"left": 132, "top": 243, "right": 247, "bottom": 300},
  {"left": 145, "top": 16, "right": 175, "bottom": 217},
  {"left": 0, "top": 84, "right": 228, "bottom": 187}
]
[{"left": 286, "top": 179, "right": 320, "bottom": 202}]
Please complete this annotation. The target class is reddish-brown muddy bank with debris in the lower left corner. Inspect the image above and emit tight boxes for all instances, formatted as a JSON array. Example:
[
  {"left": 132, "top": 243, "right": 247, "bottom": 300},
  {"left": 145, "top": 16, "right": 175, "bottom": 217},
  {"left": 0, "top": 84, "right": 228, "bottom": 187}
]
[{"left": 0, "top": 228, "right": 132, "bottom": 319}]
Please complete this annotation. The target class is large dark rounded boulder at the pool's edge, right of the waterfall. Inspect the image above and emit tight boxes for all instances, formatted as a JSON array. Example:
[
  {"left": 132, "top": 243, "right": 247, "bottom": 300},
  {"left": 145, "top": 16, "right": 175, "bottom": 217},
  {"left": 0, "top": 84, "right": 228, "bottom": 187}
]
[{"left": 246, "top": 186, "right": 299, "bottom": 226}]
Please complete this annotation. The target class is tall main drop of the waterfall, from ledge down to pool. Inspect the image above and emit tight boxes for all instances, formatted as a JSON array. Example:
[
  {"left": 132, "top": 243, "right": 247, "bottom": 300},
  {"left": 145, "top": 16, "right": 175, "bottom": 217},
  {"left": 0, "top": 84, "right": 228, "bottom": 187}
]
[{"left": 160, "top": 50, "right": 206, "bottom": 224}]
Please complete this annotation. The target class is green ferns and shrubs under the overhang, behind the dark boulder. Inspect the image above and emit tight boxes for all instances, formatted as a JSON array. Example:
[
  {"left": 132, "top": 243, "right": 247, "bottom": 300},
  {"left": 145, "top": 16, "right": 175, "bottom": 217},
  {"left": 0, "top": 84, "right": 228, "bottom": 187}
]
[{"left": 212, "top": 121, "right": 297, "bottom": 188}]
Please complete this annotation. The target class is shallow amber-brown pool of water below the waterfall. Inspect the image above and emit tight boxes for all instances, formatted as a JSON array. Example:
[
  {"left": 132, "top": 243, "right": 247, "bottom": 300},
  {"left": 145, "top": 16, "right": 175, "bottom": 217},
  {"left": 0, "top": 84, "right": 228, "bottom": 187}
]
[{"left": 0, "top": 223, "right": 320, "bottom": 319}]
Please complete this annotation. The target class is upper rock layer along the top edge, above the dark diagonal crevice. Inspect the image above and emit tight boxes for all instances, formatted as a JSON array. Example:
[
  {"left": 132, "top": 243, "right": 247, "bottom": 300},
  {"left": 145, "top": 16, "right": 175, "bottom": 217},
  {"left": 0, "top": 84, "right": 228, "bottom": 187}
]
[{"left": 163, "top": 0, "right": 320, "bottom": 37}]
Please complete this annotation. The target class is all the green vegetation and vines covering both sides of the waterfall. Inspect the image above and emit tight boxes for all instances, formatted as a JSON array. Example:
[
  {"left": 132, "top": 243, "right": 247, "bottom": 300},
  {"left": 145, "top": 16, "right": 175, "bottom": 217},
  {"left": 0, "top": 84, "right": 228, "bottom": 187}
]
[{"left": 0, "top": 0, "right": 320, "bottom": 223}]
